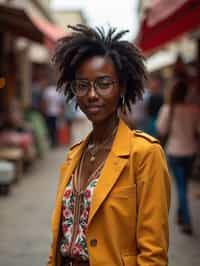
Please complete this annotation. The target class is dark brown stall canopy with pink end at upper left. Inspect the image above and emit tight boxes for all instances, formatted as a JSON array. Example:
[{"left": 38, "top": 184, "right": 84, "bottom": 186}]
[{"left": 0, "top": 5, "right": 65, "bottom": 48}]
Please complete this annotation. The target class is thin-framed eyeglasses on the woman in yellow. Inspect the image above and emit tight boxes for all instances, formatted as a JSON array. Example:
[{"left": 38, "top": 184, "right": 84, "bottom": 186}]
[{"left": 71, "top": 77, "right": 118, "bottom": 97}]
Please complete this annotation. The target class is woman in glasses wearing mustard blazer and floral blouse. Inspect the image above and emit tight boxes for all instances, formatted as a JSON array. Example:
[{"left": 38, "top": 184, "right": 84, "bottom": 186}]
[{"left": 48, "top": 25, "right": 170, "bottom": 266}]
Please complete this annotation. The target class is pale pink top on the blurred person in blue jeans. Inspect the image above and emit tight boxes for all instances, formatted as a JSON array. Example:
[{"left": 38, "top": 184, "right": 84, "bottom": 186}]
[{"left": 156, "top": 104, "right": 200, "bottom": 156}]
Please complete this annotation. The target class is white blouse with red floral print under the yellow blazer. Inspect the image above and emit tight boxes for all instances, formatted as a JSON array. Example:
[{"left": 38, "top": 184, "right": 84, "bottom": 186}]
[{"left": 60, "top": 162, "right": 103, "bottom": 260}]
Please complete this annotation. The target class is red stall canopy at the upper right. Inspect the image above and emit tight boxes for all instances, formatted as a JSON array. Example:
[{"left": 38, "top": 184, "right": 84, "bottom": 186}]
[{"left": 135, "top": 0, "right": 200, "bottom": 54}]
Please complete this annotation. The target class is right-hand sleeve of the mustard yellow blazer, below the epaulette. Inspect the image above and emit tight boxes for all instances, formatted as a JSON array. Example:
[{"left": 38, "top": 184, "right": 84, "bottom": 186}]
[{"left": 137, "top": 143, "right": 170, "bottom": 266}]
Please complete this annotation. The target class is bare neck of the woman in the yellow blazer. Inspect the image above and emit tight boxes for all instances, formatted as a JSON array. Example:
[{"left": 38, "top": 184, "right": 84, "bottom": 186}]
[{"left": 92, "top": 114, "right": 119, "bottom": 143}]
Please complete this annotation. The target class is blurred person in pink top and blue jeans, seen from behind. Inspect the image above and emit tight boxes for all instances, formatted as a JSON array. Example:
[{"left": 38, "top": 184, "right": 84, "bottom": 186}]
[{"left": 157, "top": 79, "right": 200, "bottom": 234}]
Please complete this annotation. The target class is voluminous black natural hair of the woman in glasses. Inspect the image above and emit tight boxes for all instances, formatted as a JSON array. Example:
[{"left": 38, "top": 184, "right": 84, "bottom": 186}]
[{"left": 53, "top": 24, "right": 146, "bottom": 109}]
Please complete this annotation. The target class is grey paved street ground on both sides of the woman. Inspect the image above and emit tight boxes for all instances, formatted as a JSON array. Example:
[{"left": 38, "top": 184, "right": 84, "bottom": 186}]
[{"left": 0, "top": 149, "right": 200, "bottom": 266}]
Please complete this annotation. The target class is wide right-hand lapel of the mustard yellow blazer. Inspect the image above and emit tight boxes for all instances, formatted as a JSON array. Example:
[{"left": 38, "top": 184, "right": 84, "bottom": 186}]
[{"left": 88, "top": 120, "right": 133, "bottom": 226}]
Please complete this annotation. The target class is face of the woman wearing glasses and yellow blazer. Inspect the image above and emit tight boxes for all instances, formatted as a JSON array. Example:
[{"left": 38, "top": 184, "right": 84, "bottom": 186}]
[{"left": 75, "top": 56, "right": 122, "bottom": 124}]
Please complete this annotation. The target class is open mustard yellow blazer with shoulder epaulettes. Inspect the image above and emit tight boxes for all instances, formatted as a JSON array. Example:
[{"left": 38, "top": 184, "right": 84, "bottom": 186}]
[{"left": 48, "top": 120, "right": 170, "bottom": 266}]
